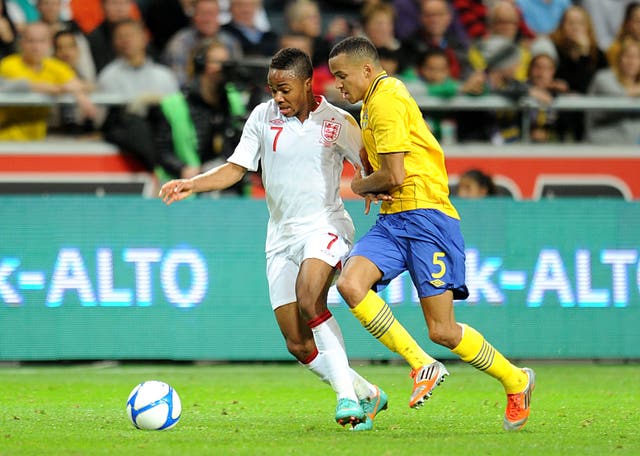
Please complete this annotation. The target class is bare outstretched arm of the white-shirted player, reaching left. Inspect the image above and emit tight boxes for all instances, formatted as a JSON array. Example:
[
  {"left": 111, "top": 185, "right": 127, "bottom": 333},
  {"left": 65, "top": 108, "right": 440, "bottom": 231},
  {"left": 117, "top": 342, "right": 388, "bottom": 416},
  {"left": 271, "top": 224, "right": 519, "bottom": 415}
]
[{"left": 159, "top": 162, "right": 247, "bottom": 204}]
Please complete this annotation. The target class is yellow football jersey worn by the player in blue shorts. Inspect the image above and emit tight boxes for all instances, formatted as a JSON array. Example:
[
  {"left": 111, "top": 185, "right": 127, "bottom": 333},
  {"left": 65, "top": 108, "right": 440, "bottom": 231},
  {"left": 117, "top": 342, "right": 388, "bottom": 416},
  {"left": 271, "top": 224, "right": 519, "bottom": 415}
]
[{"left": 360, "top": 72, "right": 460, "bottom": 218}]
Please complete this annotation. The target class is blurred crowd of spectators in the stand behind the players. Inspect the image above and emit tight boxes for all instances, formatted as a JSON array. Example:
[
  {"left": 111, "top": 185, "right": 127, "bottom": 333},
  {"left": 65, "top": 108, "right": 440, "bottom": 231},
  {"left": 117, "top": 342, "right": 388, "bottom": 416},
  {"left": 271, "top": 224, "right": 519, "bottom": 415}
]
[{"left": 0, "top": 0, "right": 640, "bottom": 183}]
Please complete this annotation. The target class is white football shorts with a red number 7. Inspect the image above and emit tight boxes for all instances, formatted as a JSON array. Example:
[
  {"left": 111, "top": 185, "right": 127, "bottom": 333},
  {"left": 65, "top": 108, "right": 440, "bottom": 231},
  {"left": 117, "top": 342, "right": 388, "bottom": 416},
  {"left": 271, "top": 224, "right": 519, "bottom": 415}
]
[{"left": 267, "top": 230, "right": 351, "bottom": 310}]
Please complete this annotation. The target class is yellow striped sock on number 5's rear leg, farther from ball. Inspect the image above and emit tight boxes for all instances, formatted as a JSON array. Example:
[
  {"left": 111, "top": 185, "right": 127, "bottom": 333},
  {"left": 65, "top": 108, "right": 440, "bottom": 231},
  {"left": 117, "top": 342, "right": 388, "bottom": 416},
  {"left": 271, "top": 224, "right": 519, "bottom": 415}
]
[{"left": 451, "top": 324, "right": 528, "bottom": 394}]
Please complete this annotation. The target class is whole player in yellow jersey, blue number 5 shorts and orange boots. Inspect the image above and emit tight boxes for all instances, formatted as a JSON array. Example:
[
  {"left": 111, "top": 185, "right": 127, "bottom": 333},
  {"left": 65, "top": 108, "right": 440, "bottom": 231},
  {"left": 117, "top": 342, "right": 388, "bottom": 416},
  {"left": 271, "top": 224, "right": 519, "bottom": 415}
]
[{"left": 329, "top": 37, "right": 535, "bottom": 430}]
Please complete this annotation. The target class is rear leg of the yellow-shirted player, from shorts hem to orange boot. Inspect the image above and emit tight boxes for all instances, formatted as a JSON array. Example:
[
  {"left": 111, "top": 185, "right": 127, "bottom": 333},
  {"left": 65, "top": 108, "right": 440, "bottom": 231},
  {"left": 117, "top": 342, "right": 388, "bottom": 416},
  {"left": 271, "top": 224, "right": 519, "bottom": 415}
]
[{"left": 420, "top": 291, "right": 535, "bottom": 431}]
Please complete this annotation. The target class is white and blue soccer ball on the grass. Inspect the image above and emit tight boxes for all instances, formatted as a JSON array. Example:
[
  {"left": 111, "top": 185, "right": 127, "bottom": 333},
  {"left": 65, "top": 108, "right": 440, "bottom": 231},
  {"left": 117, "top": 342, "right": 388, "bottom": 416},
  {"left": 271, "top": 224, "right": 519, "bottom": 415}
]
[{"left": 127, "top": 380, "right": 182, "bottom": 431}]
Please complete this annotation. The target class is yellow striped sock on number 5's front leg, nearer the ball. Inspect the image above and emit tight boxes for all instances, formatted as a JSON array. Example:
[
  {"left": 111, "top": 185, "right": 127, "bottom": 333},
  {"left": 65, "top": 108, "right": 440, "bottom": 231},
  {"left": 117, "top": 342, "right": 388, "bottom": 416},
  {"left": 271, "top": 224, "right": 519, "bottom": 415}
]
[{"left": 351, "top": 290, "right": 435, "bottom": 369}]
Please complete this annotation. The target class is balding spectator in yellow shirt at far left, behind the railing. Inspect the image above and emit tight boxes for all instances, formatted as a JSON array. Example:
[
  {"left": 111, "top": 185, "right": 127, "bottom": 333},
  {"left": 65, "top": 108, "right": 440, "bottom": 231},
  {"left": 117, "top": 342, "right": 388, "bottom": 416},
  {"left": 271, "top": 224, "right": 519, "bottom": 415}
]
[{"left": 0, "top": 22, "right": 96, "bottom": 141}]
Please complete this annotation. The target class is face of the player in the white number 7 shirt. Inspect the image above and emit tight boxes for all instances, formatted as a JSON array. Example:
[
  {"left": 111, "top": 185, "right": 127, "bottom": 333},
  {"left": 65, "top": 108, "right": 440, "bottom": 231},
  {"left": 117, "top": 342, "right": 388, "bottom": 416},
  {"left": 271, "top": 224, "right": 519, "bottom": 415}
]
[{"left": 268, "top": 68, "right": 311, "bottom": 121}]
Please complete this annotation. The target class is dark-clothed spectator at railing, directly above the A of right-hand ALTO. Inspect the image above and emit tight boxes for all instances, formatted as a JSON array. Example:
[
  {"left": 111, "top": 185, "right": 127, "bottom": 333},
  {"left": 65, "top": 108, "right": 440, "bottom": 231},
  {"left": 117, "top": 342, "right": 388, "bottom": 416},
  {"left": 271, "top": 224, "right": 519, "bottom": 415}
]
[{"left": 527, "top": 53, "right": 569, "bottom": 142}]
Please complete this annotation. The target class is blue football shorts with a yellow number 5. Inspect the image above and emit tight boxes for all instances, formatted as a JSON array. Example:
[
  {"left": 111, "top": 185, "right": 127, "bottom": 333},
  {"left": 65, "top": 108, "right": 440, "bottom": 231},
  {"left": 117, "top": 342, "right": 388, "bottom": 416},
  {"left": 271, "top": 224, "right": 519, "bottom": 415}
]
[{"left": 349, "top": 209, "right": 469, "bottom": 299}]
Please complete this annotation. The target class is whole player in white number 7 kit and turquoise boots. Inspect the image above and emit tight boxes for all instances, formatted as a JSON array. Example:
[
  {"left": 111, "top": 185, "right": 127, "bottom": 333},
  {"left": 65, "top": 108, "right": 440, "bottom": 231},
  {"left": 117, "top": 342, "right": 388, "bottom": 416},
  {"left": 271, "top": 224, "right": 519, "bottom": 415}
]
[{"left": 160, "top": 48, "right": 387, "bottom": 430}]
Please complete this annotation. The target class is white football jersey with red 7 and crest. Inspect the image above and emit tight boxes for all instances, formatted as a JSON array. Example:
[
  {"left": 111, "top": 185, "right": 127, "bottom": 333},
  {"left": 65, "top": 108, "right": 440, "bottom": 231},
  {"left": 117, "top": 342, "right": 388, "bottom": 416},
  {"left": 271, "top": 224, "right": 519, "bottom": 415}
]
[{"left": 228, "top": 97, "right": 362, "bottom": 253}]
